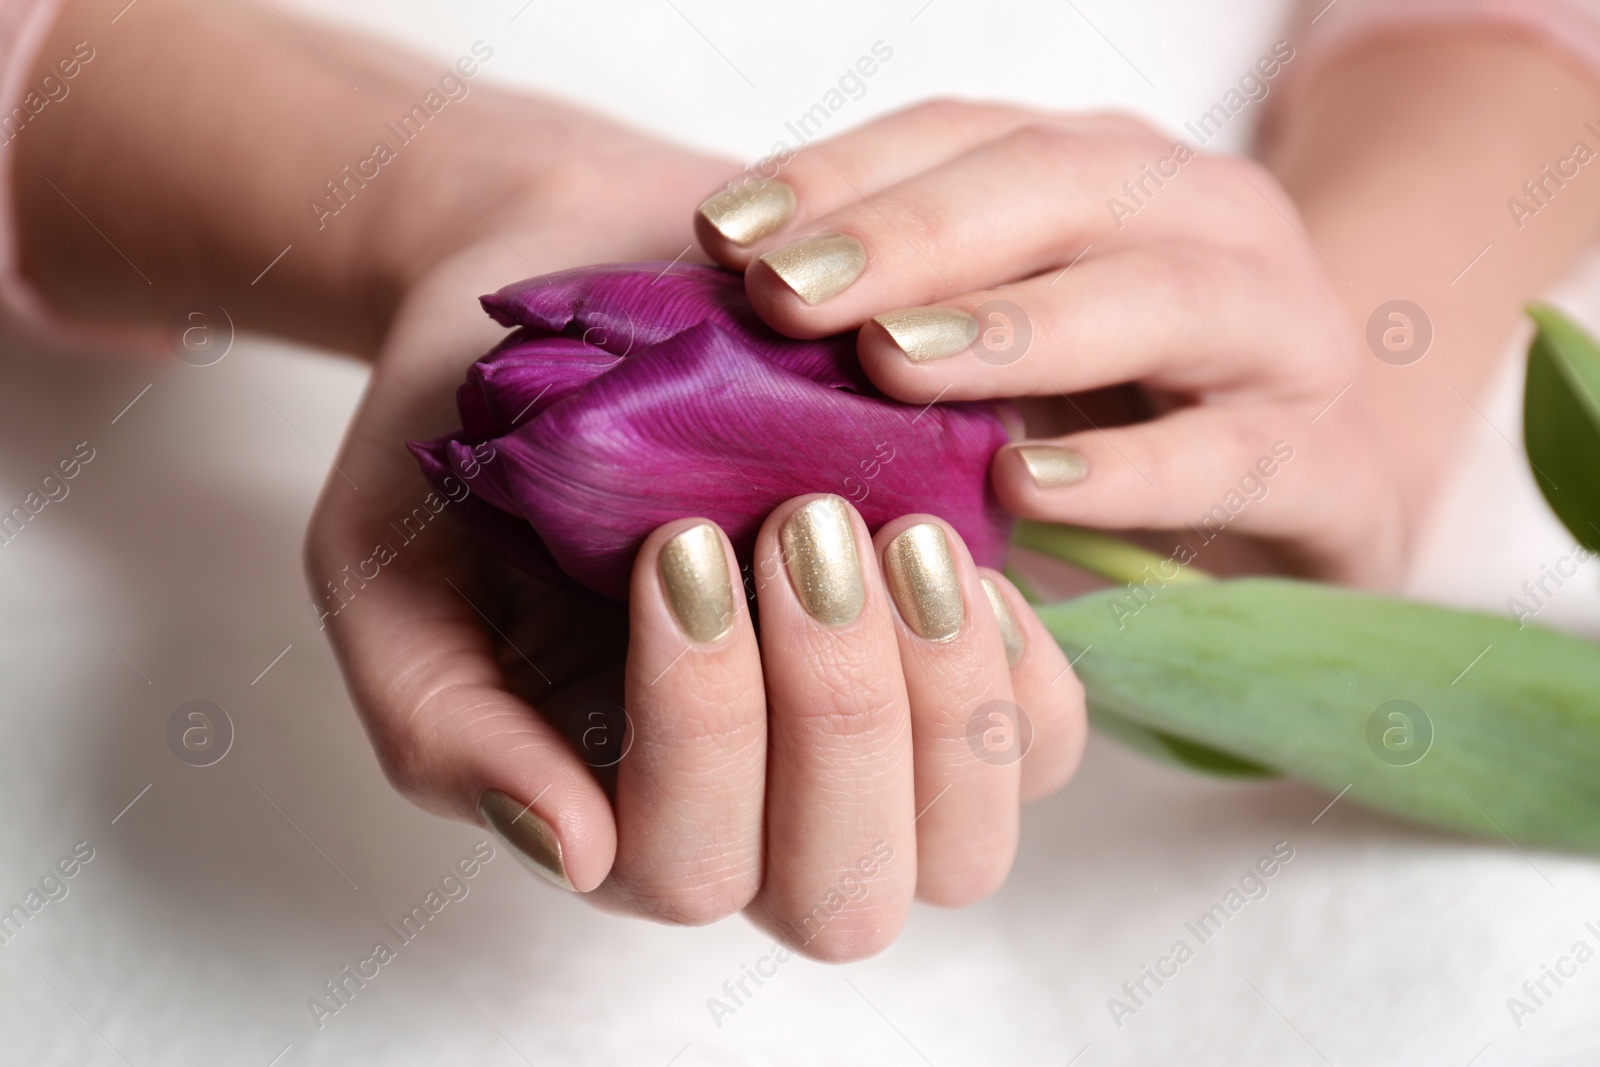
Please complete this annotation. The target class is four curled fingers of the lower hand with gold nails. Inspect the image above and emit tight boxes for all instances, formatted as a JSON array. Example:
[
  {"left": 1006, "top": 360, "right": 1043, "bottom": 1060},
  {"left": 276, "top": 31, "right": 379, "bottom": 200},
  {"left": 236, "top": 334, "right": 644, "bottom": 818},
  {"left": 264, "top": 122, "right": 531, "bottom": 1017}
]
[{"left": 601, "top": 496, "right": 1085, "bottom": 960}]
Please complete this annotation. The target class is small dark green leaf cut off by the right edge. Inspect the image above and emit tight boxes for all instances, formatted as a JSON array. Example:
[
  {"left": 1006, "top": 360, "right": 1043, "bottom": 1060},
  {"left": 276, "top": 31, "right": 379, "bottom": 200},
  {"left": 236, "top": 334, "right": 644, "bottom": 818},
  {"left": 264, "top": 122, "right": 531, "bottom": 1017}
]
[{"left": 1523, "top": 306, "right": 1600, "bottom": 552}]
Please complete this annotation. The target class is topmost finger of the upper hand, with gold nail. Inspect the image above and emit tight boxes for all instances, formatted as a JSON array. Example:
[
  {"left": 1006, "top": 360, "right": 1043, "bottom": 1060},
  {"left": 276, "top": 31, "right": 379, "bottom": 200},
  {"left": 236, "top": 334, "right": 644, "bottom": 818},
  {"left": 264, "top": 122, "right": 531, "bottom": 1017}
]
[{"left": 694, "top": 101, "right": 1040, "bottom": 270}]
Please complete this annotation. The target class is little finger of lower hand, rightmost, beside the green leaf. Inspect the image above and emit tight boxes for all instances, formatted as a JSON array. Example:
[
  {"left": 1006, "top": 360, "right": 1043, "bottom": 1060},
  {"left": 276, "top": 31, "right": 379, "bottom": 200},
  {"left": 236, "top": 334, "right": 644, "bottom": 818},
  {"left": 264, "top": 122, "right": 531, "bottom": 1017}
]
[{"left": 978, "top": 568, "right": 1088, "bottom": 803}]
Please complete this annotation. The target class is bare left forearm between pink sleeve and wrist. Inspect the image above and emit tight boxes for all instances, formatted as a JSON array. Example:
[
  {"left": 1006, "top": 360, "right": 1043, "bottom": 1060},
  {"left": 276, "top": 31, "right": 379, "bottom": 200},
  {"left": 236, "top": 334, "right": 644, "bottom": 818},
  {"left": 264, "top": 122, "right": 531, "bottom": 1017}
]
[{"left": 14, "top": 0, "right": 713, "bottom": 355}]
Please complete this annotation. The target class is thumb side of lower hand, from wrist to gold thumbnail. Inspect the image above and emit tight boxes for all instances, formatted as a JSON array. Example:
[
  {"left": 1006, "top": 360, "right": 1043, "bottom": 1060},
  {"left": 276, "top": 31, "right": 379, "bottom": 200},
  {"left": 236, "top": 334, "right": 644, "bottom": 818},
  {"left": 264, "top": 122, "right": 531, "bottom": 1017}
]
[{"left": 306, "top": 233, "right": 630, "bottom": 893}]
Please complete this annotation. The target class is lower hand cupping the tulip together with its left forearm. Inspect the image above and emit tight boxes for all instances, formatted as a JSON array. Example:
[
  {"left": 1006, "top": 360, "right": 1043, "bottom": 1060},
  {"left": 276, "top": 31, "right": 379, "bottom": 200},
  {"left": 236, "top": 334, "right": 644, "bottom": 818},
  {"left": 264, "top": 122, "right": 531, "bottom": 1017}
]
[{"left": 18, "top": 0, "right": 1085, "bottom": 958}]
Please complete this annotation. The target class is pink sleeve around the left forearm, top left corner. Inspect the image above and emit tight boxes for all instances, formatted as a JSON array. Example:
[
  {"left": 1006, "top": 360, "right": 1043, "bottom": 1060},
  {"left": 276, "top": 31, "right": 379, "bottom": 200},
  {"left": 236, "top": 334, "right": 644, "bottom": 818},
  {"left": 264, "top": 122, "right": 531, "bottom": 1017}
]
[{"left": 0, "top": 0, "right": 166, "bottom": 354}]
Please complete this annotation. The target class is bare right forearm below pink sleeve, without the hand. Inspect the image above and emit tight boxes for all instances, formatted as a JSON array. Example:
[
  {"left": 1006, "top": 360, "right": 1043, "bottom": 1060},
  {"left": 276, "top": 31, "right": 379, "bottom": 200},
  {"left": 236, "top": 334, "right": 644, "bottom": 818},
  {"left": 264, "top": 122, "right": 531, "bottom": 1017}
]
[{"left": 1264, "top": 27, "right": 1600, "bottom": 523}]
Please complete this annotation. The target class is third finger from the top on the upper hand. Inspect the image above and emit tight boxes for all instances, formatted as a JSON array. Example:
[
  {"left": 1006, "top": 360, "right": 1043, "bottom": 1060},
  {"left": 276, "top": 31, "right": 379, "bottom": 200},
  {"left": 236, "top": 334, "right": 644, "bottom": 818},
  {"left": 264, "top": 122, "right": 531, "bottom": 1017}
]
[{"left": 858, "top": 243, "right": 1350, "bottom": 403}]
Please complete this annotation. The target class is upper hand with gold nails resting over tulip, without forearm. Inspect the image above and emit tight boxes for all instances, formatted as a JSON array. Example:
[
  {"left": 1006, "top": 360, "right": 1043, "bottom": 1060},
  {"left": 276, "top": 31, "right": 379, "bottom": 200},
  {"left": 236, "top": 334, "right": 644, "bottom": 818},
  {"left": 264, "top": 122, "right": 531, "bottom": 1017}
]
[{"left": 696, "top": 102, "right": 1406, "bottom": 585}]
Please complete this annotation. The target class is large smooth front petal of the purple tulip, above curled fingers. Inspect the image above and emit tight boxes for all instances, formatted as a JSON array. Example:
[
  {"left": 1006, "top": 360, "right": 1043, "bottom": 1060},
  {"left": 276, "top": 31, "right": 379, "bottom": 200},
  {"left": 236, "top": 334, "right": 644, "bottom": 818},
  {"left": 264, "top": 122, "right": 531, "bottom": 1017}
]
[{"left": 494, "top": 322, "right": 1010, "bottom": 598}]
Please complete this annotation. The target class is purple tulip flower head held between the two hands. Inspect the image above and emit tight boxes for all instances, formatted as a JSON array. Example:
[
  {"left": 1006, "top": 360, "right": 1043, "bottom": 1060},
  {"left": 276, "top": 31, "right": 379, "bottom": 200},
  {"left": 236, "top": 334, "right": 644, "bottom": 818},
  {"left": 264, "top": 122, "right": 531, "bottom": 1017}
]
[{"left": 410, "top": 264, "right": 1011, "bottom": 598}]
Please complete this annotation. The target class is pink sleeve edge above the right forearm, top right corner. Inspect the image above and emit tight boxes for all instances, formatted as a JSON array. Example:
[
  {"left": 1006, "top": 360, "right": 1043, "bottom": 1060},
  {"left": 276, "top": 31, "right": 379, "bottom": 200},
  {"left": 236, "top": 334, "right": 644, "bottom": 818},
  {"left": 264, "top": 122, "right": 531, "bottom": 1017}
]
[{"left": 1283, "top": 0, "right": 1600, "bottom": 98}]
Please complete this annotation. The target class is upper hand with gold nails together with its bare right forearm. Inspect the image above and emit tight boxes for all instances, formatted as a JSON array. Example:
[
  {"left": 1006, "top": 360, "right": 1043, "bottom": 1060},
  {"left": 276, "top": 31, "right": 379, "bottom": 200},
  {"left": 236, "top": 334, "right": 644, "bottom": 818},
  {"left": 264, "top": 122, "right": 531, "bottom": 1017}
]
[{"left": 698, "top": 32, "right": 1600, "bottom": 587}]
